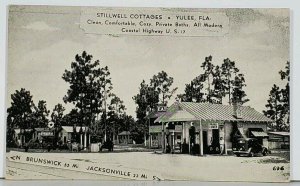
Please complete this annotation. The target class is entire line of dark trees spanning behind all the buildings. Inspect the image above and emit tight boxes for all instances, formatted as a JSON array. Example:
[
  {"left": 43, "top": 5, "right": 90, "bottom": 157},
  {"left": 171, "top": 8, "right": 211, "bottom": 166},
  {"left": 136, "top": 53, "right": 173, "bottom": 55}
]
[{"left": 7, "top": 51, "right": 289, "bottom": 147}]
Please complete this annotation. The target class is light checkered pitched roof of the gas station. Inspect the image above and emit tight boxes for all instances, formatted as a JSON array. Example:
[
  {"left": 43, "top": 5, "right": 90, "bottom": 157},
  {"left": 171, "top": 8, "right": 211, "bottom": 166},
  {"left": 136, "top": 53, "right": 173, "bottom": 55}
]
[{"left": 155, "top": 102, "right": 272, "bottom": 122}]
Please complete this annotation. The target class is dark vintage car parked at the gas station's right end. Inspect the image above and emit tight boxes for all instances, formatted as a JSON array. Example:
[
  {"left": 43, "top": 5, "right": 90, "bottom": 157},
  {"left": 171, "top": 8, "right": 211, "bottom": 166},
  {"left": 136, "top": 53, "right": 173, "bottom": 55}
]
[{"left": 233, "top": 138, "right": 270, "bottom": 157}]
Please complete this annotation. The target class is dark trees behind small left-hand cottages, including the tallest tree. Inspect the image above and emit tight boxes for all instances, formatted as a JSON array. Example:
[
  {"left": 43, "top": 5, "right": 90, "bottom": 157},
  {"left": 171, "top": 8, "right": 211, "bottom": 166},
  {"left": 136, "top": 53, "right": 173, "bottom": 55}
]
[{"left": 7, "top": 51, "right": 139, "bottom": 145}]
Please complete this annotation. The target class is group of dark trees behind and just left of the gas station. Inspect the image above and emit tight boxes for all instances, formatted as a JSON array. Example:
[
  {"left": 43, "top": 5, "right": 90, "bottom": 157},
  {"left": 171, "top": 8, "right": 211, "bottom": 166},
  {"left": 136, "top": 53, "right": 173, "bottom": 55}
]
[{"left": 133, "top": 56, "right": 249, "bottom": 132}]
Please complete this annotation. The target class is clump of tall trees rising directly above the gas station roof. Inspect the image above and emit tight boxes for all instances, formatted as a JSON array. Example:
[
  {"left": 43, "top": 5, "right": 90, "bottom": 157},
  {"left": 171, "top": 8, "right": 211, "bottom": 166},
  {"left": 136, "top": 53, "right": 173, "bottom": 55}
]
[{"left": 177, "top": 56, "right": 249, "bottom": 104}]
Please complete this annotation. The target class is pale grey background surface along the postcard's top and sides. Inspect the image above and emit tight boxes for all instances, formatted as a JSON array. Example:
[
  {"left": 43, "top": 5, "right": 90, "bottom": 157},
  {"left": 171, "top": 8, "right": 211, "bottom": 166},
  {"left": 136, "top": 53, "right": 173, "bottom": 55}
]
[{"left": 0, "top": 0, "right": 300, "bottom": 180}]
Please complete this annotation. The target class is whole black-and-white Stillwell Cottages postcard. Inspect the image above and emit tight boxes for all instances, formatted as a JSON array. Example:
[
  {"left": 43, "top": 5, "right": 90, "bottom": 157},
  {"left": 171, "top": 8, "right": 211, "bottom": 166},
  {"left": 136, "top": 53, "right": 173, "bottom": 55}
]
[{"left": 6, "top": 5, "right": 290, "bottom": 182}]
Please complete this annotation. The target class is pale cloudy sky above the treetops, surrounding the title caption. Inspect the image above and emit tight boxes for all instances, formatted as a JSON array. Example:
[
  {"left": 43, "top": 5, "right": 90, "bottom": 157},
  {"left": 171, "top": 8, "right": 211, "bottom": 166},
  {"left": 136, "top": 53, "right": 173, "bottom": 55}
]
[{"left": 7, "top": 6, "right": 290, "bottom": 117}]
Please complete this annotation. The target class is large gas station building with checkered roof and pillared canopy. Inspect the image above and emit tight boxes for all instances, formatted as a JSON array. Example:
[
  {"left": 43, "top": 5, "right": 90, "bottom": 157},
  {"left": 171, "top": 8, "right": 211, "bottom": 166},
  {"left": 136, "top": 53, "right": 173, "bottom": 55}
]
[{"left": 154, "top": 102, "right": 273, "bottom": 155}]
